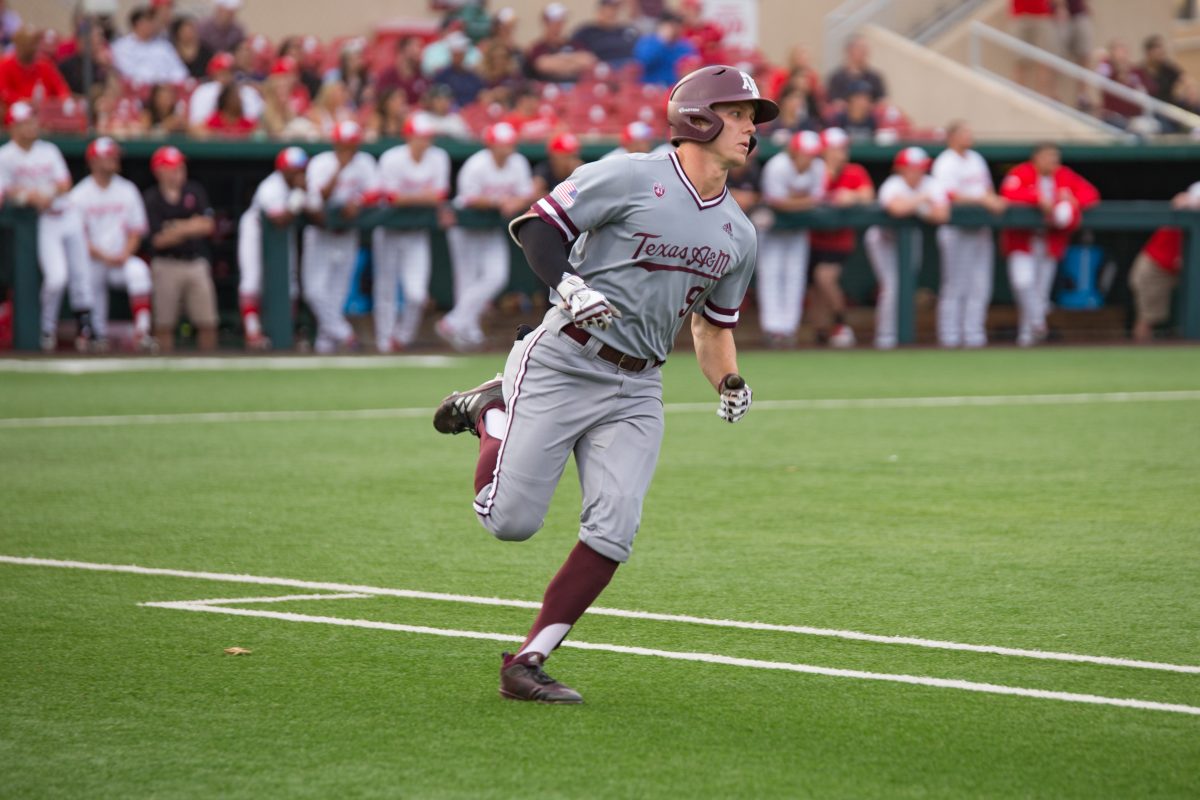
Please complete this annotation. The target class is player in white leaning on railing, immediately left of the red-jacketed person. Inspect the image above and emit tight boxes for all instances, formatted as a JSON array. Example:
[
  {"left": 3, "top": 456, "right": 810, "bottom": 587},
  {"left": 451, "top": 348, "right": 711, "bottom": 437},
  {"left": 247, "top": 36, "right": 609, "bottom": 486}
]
[{"left": 931, "top": 121, "right": 1008, "bottom": 348}]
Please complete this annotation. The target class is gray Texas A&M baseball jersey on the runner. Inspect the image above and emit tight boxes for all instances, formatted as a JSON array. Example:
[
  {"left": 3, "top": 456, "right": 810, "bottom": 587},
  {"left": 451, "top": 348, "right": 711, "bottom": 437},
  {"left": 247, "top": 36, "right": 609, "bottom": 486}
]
[{"left": 512, "top": 152, "right": 757, "bottom": 361}]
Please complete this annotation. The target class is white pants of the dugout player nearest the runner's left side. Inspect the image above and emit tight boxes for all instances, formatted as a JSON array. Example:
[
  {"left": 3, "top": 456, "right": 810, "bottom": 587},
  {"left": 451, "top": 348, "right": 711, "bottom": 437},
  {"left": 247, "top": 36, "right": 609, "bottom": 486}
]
[{"left": 445, "top": 228, "right": 509, "bottom": 344}]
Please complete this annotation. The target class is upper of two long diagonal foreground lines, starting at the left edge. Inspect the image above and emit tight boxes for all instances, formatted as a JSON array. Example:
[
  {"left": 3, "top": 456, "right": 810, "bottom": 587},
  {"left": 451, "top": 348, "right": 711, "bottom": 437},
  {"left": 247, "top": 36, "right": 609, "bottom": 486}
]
[{"left": 0, "top": 555, "right": 1200, "bottom": 674}]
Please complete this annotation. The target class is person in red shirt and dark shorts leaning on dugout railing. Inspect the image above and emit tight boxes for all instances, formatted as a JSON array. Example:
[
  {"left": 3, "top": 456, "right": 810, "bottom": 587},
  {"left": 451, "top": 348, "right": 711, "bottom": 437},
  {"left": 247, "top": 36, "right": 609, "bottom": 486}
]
[{"left": 809, "top": 128, "right": 875, "bottom": 348}]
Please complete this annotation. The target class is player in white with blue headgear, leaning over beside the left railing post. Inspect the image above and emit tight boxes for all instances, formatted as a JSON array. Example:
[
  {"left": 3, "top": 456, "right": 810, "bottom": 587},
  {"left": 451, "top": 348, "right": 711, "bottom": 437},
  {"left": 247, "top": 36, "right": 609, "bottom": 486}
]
[{"left": 238, "top": 148, "right": 308, "bottom": 350}]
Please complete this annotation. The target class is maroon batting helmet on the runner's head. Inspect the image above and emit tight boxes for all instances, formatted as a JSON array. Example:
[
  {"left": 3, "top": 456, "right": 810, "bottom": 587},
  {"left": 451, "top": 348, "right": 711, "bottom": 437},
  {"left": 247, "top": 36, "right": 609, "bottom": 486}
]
[{"left": 667, "top": 65, "right": 779, "bottom": 150}]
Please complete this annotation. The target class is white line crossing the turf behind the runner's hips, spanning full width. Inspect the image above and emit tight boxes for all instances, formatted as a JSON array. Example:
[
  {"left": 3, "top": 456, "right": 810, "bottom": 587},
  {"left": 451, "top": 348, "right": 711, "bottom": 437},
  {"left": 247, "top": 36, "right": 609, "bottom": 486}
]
[{"left": 0, "top": 390, "right": 1200, "bottom": 428}]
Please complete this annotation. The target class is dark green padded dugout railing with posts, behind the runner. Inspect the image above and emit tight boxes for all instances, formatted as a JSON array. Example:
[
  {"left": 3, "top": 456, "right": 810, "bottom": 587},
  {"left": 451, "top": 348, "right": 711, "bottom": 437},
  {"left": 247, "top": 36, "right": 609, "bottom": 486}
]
[{"left": 0, "top": 200, "right": 1200, "bottom": 351}]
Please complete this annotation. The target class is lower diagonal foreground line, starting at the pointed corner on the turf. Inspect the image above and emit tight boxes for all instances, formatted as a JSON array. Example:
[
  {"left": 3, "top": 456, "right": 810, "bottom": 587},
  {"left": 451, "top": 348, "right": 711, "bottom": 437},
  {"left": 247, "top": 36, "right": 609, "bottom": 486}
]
[{"left": 139, "top": 595, "right": 1200, "bottom": 716}]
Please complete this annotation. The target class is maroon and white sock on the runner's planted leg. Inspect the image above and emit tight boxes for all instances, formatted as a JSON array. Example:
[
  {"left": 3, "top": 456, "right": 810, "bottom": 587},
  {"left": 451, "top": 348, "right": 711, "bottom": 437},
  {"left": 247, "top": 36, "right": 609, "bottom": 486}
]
[{"left": 517, "top": 542, "right": 620, "bottom": 656}]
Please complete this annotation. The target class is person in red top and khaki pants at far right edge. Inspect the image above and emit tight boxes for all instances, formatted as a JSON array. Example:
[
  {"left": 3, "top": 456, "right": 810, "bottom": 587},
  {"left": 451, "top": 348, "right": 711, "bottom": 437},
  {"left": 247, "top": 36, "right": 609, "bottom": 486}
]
[{"left": 1129, "top": 181, "right": 1200, "bottom": 343}]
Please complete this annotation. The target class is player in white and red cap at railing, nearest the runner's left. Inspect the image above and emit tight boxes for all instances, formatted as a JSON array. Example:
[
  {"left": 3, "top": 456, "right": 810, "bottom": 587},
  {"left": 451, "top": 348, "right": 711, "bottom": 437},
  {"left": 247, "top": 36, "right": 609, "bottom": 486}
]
[{"left": 437, "top": 122, "right": 533, "bottom": 350}]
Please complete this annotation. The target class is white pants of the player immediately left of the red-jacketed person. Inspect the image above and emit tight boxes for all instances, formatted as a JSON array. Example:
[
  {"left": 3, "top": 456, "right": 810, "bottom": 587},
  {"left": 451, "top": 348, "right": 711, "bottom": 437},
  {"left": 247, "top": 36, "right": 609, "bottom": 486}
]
[{"left": 937, "top": 227, "right": 996, "bottom": 348}]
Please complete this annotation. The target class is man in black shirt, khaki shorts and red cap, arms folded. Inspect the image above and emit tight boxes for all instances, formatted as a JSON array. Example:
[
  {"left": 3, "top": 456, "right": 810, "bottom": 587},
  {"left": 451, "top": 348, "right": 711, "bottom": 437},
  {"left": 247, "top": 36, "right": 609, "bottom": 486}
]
[{"left": 145, "top": 146, "right": 217, "bottom": 353}]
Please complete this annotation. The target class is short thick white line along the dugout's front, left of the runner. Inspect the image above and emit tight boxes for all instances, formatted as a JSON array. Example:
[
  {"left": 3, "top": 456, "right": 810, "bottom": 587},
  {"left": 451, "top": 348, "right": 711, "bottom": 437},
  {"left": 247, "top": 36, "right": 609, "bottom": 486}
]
[{"left": 0, "top": 355, "right": 455, "bottom": 375}]
